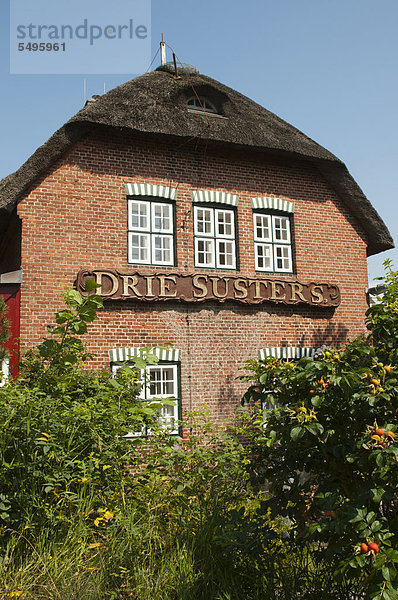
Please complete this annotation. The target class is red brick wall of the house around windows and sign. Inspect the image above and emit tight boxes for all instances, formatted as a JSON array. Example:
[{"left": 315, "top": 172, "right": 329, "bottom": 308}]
[{"left": 19, "top": 133, "right": 367, "bottom": 417}]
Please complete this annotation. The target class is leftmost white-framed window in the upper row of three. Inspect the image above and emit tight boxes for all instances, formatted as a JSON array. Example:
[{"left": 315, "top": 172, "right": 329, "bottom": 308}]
[{"left": 128, "top": 198, "right": 175, "bottom": 265}]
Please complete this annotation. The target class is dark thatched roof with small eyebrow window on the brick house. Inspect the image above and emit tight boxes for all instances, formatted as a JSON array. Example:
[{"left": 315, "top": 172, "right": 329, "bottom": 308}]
[{"left": 0, "top": 65, "right": 394, "bottom": 255}]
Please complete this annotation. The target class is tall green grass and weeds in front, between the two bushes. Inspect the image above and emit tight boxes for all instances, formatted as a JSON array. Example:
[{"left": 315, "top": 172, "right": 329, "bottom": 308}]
[{"left": 0, "top": 436, "right": 364, "bottom": 600}]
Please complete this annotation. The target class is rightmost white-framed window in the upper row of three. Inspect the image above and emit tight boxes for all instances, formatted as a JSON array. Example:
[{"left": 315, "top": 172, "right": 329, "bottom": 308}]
[{"left": 253, "top": 212, "right": 293, "bottom": 273}]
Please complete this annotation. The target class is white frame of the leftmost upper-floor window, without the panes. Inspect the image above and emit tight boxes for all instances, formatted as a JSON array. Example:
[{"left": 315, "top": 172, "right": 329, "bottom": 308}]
[{"left": 127, "top": 197, "right": 175, "bottom": 266}]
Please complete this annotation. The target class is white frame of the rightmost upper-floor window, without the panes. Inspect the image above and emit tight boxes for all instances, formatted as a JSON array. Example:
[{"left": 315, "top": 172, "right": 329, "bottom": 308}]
[{"left": 253, "top": 210, "right": 293, "bottom": 273}]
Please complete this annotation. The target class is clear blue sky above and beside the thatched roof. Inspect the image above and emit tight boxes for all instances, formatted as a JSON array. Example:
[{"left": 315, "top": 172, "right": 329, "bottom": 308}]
[{"left": 0, "top": 0, "right": 398, "bottom": 282}]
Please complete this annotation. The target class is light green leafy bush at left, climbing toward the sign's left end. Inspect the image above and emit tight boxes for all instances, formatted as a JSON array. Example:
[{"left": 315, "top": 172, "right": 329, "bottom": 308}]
[{"left": 0, "top": 281, "right": 162, "bottom": 529}]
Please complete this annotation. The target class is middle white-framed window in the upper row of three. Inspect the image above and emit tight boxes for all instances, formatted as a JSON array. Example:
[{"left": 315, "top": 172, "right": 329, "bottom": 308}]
[{"left": 194, "top": 206, "right": 236, "bottom": 269}]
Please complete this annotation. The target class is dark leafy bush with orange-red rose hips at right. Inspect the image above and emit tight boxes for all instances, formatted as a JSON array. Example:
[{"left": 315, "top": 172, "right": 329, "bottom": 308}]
[{"left": 241, "top": 263, "right": 398, "bottom": 600}]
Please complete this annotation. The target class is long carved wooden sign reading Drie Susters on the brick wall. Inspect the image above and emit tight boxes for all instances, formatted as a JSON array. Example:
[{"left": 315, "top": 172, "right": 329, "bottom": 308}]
[{"left": 76, "top": 269, "right": 341, "bottom": 307}]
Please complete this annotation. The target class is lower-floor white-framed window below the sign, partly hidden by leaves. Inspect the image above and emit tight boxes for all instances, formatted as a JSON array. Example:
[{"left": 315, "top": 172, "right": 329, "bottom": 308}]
[{"left": 112, "top": 362, "right": 181, "bottom": 438}]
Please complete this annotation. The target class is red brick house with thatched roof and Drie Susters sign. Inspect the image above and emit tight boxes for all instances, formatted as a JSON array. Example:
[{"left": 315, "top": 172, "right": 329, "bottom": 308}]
[{"left": 0, "top": 65, "right": 393, "bottom": 419}]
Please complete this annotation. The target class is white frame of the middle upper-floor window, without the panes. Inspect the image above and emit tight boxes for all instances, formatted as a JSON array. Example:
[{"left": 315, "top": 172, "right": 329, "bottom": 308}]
[{"left": 194, "top": 205, "right": 236, "bottom": 270}]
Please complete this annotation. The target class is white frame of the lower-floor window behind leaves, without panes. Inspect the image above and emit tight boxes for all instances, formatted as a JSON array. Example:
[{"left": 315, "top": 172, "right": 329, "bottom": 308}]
[{"left": 111, "top": 361, "right": 181, "bottom": 438}]
